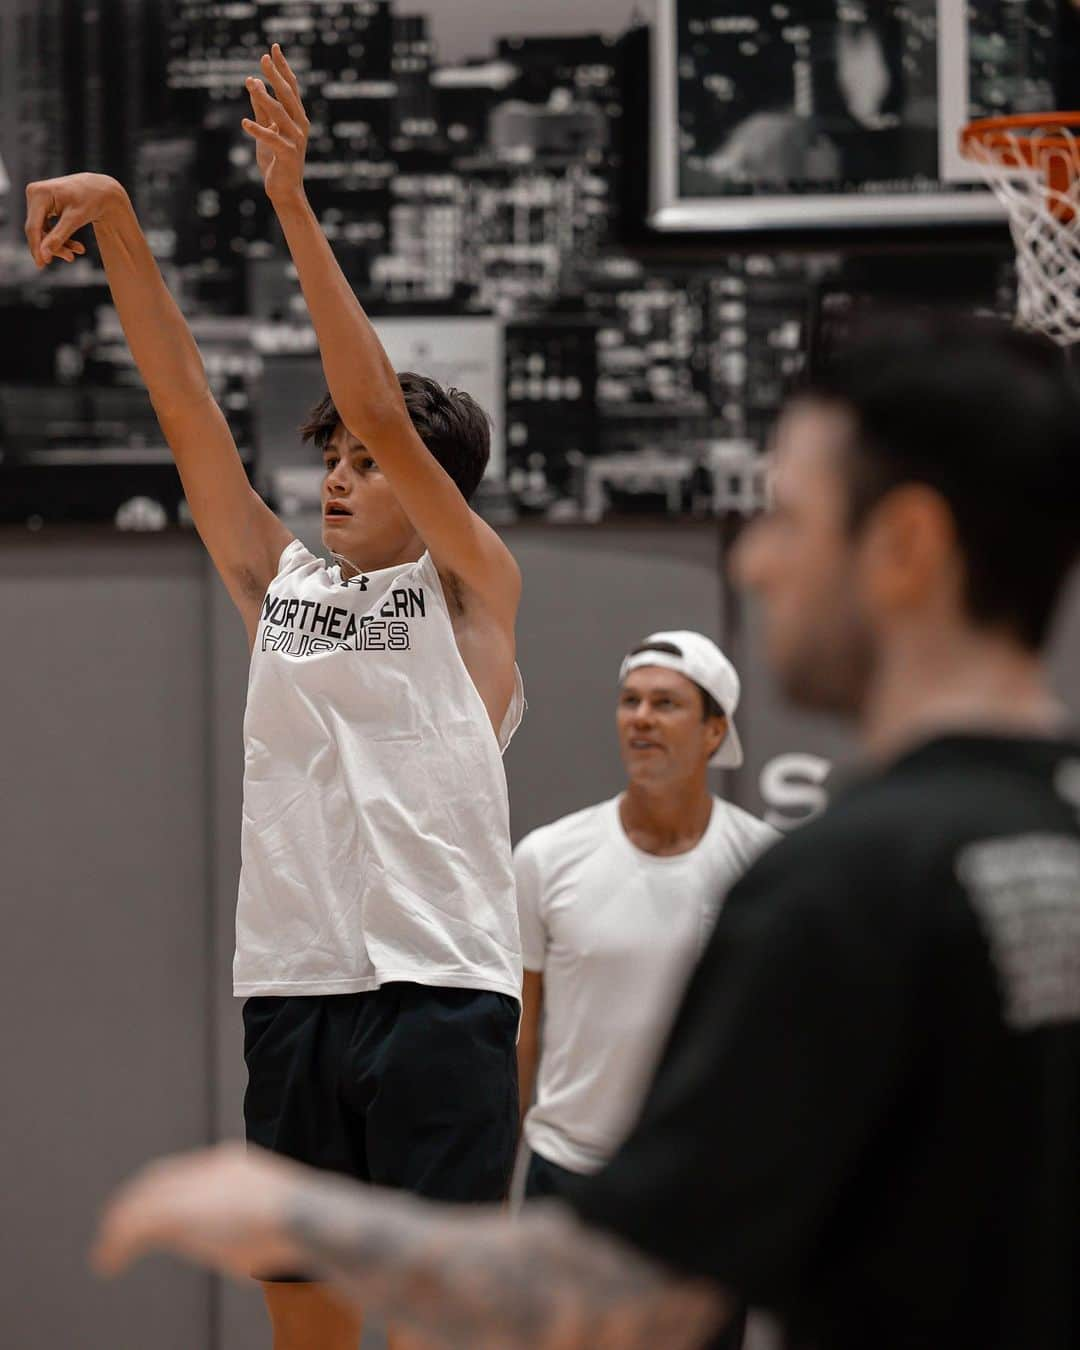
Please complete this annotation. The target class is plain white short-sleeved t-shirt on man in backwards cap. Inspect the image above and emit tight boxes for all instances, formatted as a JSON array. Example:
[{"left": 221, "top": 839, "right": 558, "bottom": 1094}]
[{"left": 514, "top": 798, "right": 778, "bottom": 1172}]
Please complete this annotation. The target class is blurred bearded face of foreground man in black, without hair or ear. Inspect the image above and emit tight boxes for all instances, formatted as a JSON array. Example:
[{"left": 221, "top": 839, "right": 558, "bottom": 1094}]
[{"left": 734, "top": 401, "right": 873, "bottom": 713}]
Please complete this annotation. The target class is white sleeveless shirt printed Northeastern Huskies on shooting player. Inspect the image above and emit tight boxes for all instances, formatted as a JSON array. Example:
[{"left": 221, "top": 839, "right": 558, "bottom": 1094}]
[{"left": 234, "top": 540, "right": 524, "bottom": 998}]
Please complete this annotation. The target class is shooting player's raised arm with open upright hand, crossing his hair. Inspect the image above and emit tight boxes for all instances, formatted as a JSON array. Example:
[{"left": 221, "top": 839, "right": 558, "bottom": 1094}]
[{"left": 243, "top": 43, "right": 521, "bottom": 617}]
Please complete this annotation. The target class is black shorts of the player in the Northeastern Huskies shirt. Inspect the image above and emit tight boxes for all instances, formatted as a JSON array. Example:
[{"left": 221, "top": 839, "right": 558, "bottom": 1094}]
[{"left": 243, "top": 983, "right": 518, "bottom": 1236}]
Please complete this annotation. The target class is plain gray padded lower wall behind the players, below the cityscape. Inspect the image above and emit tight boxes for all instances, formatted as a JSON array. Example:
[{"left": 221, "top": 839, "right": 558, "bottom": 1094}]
[{"left": 0, "top": 521, "right": 1080, "bottom": 1350}]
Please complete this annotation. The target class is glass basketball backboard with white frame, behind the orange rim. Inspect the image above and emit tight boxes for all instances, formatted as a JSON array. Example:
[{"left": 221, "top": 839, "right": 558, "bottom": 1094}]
[{"left": 649, "top": 0, "right": 1060, "bottom": 231}]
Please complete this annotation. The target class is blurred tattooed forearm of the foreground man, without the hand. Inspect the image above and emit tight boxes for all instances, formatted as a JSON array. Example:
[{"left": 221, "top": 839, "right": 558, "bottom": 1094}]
[{"left": 285, "top": 1179, "right": 726, "bottom": 1350}]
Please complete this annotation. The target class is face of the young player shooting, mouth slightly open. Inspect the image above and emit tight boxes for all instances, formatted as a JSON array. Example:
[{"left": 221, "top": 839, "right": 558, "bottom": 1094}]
[{"left": 323, "top": 423, "right": 416, "bottom": 568}]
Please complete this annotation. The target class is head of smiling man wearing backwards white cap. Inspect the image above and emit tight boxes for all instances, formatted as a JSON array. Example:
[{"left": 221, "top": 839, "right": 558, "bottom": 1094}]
[{"left": 616, "top": 629, "right": 743, "bottom": 788}]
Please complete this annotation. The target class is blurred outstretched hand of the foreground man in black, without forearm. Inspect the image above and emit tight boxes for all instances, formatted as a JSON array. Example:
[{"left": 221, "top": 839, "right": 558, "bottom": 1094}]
[{"left": 92, "top": 1143, "right": 305, "bottom": 1276}]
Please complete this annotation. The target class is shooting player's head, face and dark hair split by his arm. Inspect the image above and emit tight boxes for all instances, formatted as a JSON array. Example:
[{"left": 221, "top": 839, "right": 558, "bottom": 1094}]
[{"left": 300, "top": 371, "right": 491, "bottom": 570}]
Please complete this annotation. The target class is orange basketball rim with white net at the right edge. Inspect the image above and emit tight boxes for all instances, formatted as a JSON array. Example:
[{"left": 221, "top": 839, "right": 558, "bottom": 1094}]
[{"left": 960, "top": 112, "right": 1080, "bottom": 347}]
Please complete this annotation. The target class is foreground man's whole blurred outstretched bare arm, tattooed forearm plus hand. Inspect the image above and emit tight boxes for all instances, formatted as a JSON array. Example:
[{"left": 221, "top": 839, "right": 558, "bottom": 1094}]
[{"left": 96, "top": 1145, "right": 726, "bottom": 1350}]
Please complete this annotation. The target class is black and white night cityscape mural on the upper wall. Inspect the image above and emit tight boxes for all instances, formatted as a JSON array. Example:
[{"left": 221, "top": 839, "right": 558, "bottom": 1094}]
[{"left": 0, "top": 0, "right": 1069, "bottom": 528}]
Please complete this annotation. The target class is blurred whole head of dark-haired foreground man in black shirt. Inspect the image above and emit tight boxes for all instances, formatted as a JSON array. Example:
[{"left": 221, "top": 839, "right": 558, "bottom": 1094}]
[{"left": 736, "top": 316, "right": 1080, "bottom": 714}]
